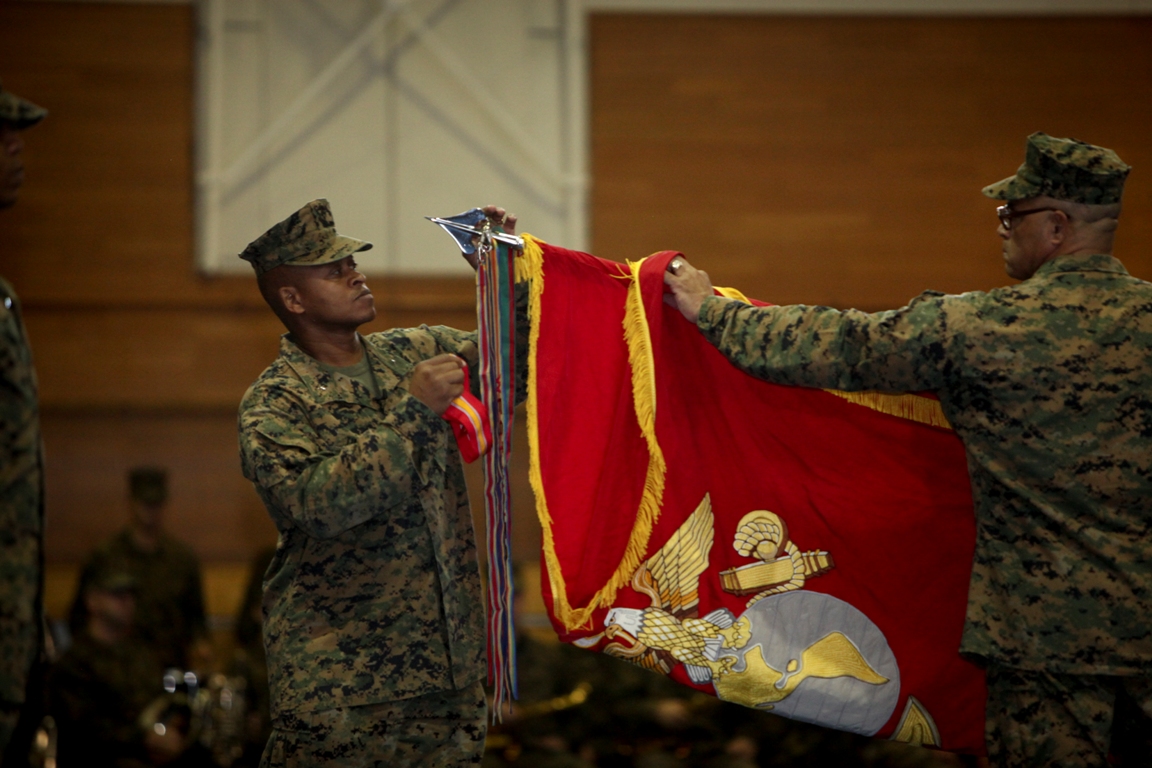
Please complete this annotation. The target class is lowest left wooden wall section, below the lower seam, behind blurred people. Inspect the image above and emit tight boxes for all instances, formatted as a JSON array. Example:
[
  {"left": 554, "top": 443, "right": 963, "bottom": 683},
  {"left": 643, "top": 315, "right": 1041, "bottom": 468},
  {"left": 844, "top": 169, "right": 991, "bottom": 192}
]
[{"left": 36, "top": 409, "right": 540, "bottom": 618}]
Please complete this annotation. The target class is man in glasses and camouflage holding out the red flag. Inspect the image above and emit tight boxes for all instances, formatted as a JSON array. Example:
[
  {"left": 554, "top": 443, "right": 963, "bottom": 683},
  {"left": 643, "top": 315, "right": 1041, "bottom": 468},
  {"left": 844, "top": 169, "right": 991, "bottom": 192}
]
[{"left": 665, "top": 132, "right": 1152, "bottom": 766}]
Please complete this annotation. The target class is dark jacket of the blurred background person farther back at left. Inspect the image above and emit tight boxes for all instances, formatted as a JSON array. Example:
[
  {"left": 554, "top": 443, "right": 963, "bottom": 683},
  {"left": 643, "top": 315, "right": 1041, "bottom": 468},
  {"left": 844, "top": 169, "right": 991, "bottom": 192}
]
[{"left": 71, "top": 527, "right": 207, "bottom": 669}]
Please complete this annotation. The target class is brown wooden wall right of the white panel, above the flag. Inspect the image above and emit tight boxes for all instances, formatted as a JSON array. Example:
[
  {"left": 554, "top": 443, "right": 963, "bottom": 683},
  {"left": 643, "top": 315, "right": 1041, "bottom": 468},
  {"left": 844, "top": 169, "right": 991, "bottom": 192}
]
[{"left": 590, "top": 14, "right": 1152, "bottom": 309}]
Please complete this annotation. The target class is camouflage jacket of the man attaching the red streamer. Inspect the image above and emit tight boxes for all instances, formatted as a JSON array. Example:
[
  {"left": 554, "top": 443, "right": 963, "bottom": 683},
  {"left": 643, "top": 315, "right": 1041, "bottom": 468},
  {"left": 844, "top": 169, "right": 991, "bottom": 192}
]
[{"left": 240, "top": 292, "right": 528, "bottom": 717}]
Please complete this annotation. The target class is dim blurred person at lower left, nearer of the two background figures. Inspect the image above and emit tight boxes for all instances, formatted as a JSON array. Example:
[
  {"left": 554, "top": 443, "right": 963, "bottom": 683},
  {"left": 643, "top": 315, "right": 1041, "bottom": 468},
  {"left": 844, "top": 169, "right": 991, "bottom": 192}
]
[{"left": 48, "top": 570, "right": 164, "bottom": 768}]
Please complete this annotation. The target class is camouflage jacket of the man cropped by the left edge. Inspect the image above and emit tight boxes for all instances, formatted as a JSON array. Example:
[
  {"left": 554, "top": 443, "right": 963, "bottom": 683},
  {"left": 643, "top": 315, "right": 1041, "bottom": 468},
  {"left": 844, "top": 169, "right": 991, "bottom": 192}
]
[{"left": 0, "top": 279, "right": 44, "bottom": 702}]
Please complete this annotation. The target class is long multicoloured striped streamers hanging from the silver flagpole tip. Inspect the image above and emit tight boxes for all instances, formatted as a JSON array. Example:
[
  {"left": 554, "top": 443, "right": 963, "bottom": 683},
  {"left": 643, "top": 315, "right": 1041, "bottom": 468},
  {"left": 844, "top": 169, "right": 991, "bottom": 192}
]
[{"left": 476, "top": 238, "right": 517, "bottom": 722}]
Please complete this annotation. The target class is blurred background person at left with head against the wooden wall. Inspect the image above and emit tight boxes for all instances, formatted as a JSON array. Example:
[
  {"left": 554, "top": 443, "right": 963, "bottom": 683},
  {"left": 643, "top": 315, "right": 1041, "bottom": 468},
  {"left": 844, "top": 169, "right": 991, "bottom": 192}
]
[{"left": 71, "top": 466, "right": 211, "bottom": 669}]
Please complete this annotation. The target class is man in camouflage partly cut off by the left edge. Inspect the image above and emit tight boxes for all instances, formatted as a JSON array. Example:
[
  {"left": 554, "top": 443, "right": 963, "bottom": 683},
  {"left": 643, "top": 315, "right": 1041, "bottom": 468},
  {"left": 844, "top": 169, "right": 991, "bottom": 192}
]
[{"left": 0, "top": 76, "right": 47, "bottom": 766}]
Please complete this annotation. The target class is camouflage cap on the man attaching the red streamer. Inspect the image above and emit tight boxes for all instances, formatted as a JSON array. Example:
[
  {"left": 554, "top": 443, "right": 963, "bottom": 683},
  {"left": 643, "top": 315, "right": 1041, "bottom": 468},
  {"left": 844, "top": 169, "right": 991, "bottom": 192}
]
[{"left": 240, "top": 198, "right": 372, "bottom": 275}]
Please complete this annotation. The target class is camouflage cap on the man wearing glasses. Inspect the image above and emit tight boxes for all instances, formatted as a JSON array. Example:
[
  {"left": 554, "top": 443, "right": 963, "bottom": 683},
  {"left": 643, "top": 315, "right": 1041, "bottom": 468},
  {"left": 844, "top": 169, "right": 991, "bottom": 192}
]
[{"left": 982, "top": 132, "right": 1131, "bottom": 205}]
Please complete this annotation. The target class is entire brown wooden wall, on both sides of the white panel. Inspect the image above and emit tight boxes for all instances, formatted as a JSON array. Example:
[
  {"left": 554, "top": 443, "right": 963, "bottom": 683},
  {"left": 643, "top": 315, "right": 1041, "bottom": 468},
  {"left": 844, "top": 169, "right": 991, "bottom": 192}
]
[{"left": 0, "top": 1, "right": 1152, "bottom": 615}]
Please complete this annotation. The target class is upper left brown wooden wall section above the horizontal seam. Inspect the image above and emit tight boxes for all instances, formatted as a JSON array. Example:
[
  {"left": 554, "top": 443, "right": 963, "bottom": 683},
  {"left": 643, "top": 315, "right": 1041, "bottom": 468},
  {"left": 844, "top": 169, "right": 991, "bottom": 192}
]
[{"left": 0, "top": 2, "right": 202, "bottom": 302}]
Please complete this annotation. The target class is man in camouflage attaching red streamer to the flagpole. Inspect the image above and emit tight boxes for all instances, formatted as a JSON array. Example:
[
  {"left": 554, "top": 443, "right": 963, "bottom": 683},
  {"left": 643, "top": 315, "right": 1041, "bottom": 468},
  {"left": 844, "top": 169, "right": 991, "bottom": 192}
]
[{"left": 240, "top": 199, "right": 528, "bottom": 767}]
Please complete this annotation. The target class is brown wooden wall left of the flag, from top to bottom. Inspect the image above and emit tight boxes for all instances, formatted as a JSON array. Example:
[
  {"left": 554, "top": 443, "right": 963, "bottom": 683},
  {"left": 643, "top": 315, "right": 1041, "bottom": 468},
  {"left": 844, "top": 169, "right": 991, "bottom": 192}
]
[{"left": 0, "top": 1, "right": 539, "bottom": 594}]
